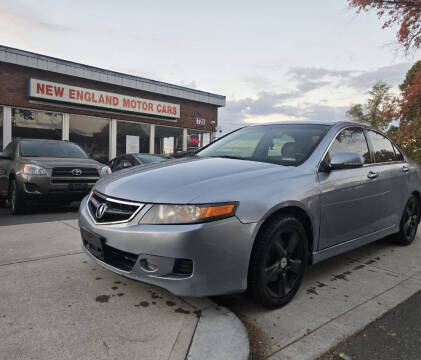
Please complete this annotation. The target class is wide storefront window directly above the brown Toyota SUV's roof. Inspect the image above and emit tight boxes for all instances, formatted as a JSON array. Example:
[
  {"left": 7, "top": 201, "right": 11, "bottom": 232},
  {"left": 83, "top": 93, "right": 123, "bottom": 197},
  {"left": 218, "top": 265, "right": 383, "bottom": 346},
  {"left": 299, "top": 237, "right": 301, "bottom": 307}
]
[{"left": 12, "top": 108, "right": 63, "bottom": 140}]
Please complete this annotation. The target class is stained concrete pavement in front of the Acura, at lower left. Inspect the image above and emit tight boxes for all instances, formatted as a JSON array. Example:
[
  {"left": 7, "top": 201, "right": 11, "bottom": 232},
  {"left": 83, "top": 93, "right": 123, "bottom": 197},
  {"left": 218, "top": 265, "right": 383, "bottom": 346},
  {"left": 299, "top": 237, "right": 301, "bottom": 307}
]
[{"left": 0, "top": 220, "right": 249, "bottom": 360}]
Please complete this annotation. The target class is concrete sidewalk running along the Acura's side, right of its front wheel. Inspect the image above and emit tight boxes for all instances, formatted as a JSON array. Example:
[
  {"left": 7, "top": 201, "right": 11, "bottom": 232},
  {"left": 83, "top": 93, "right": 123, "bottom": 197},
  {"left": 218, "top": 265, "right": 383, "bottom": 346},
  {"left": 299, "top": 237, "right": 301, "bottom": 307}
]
[{"left": 216, "top": 231, "right": 421, "bottom": 360}]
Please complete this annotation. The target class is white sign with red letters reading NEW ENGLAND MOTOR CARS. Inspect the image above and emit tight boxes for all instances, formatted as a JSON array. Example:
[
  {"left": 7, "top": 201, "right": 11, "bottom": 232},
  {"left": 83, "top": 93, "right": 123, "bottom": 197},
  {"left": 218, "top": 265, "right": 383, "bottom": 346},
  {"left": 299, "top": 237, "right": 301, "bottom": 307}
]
[{"left": 29, "top": 79, "right": 180, "bottom": 118}]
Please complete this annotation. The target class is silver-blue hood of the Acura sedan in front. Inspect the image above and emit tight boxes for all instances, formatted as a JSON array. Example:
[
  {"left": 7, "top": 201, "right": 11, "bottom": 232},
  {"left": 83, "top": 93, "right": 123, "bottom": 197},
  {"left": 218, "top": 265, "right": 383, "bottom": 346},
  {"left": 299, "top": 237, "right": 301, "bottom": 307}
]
[{"left": 95, "top": 158, "right": 290, "bottom": 204}]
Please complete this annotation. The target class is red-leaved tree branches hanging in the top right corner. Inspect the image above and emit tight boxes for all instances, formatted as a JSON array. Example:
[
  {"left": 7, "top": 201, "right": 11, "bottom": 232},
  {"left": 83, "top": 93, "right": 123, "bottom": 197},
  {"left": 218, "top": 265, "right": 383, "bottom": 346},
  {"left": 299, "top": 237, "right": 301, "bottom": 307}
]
[{"left": 348, "top": 0, "right": 421, "bottom": 52}]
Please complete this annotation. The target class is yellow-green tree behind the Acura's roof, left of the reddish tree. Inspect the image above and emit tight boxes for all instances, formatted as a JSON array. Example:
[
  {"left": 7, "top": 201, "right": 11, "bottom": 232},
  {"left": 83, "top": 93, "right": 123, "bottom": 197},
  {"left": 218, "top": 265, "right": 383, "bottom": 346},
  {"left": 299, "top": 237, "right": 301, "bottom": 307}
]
[{"left": 346, "top": 81, "right": 391, "bottom": 130}]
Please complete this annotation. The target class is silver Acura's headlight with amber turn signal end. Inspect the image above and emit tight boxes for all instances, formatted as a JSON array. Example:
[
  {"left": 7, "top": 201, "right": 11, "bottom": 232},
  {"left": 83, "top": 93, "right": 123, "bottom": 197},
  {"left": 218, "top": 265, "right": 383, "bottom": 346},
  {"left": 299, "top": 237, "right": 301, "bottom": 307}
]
[{"left": 139, "top": 203, "right": 237, "bottom": 224}]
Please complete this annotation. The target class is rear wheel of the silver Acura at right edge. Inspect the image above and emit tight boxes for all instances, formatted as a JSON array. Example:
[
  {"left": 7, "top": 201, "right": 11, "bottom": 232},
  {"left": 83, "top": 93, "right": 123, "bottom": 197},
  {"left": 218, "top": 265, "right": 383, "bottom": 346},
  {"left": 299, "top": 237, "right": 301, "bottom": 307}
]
[{"left": 393, "top": 195, "right": 420, "bottom": 246}]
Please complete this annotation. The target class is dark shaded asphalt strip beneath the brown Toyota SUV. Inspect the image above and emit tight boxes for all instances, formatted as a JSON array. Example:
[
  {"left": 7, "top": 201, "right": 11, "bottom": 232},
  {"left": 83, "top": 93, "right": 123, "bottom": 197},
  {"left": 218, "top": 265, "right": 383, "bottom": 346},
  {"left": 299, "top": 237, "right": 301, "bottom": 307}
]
[{"left": 0, "top": 202, "right": 80, "bottom": 226}]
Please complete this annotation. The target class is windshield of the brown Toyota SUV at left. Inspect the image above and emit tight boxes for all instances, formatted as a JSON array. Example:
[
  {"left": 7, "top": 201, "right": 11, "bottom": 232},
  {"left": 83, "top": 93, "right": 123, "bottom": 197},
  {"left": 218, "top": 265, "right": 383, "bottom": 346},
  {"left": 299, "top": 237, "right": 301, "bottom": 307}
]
[{"left": 19, "top": 140, "right": 88, "bottom": 159}]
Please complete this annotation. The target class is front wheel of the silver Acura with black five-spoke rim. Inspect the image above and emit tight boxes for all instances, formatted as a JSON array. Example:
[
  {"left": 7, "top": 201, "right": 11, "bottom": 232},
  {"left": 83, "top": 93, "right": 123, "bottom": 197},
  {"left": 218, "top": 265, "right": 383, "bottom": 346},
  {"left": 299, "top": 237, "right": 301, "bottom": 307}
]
[{"left": 247, "top": 216, "right": 309, "bottom": 309}]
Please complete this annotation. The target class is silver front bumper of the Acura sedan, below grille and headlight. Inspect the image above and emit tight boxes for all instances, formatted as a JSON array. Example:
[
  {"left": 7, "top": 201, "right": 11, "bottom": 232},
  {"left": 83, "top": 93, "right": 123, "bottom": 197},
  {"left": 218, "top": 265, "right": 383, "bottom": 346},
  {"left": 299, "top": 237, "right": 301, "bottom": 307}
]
[{"left": 79, "top": 198, "right": 256, "bottom": 296}]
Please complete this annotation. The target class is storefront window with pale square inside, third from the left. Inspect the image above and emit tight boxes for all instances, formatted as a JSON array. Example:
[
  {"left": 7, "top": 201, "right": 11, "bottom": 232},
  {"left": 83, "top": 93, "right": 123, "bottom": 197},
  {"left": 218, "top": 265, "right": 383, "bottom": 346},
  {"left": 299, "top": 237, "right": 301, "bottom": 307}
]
[{"left": 117, "top": 121, "right": 151, "bottom": 156}]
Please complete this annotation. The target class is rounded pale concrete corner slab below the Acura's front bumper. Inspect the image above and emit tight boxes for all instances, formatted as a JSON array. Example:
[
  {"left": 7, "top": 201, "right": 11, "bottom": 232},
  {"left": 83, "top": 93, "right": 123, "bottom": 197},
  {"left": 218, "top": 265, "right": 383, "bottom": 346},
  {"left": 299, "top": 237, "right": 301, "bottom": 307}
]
[{"left": 184, "top": 299, "right": 250, "bottom": 360}]
